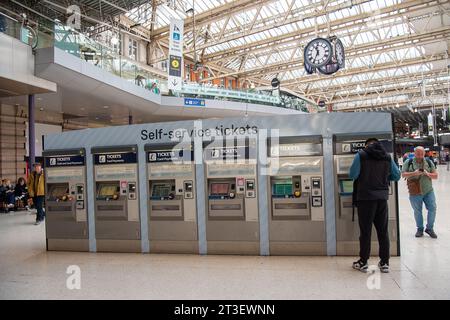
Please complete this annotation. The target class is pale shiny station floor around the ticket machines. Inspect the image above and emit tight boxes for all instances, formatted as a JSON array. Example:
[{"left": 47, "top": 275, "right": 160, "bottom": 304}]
[{"left": 0, "top": 166, "right": 450, "bottom": 300}]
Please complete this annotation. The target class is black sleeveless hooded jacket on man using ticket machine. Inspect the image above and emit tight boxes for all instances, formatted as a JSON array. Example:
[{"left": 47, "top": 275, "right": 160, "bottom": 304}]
[{"left": 355, "top": 142, "right": 391, "bottom": 201}]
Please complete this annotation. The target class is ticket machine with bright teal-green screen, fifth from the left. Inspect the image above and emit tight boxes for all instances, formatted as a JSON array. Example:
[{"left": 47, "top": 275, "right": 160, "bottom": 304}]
[{"left": 267, "top": 136, "right": 327, "bottom": 255}]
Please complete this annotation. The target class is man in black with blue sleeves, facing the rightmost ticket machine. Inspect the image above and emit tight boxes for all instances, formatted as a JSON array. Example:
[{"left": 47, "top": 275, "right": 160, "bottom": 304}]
[{"left": 349, "top": 138, "right": 400, "bottom": 272}]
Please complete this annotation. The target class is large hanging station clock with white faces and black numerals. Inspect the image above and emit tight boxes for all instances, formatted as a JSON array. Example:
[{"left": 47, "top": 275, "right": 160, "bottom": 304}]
[{"left": 304, "top": 36, "right": 345, "bottom": 75}]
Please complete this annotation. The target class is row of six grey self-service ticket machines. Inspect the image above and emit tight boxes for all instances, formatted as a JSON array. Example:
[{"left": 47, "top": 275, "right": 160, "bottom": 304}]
[{"left": 44, "top": 136, "right": 398, "bottom": 255}]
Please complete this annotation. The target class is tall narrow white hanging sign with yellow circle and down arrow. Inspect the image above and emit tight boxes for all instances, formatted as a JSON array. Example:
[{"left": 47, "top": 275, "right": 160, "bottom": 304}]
[{"left": 168, "top": 18, "right": 184, "bottom": 90}]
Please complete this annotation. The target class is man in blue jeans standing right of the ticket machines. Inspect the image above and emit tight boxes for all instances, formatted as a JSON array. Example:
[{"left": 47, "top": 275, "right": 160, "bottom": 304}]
[{"left": 402, "top": 147, "right": 438, "bottom": 239}]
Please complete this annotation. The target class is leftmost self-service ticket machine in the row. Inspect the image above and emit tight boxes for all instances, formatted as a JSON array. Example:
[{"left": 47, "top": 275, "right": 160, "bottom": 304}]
[{"left": 43, "top": 149, "right": 89, "bottom": 251}]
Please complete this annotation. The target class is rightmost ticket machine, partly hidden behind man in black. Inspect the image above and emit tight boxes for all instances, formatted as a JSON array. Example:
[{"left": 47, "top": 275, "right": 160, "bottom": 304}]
[{"left": 334, "top": 134, "right": 400, "bottom": 256}]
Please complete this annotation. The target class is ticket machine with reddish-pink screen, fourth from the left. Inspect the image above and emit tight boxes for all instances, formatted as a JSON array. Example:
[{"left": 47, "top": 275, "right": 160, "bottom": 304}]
[{"left": 204, "top": 139, "right": 260, "bottom": 254}]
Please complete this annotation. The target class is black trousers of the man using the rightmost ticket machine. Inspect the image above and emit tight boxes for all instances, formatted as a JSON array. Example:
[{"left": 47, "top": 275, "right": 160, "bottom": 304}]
[{"left": 358, "top": 200, "right": 389, "bottom": 262}]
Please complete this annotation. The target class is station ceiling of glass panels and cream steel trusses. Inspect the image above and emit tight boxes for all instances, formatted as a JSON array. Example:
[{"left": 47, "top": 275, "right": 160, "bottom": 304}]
[{"left": 3, "top": 0, "right": 450, "bottom": 115}]
